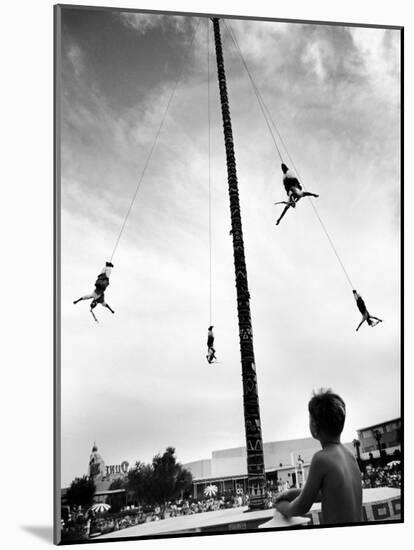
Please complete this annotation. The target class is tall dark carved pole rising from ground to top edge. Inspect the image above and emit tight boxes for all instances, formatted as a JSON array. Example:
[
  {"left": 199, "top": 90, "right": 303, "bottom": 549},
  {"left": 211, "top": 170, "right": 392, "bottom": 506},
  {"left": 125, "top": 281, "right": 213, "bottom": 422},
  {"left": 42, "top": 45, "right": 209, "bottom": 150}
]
[{"left": 213, "top": 18, "right": 266, "bottom": 510}]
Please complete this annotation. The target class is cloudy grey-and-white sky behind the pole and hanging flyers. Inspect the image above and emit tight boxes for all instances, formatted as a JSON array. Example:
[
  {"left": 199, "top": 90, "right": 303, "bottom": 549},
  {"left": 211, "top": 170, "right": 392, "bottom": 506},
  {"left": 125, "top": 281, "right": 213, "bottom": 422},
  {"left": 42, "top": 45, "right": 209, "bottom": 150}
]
[{"left": 61, "top": 9, "right": 400, "bottom": 486}]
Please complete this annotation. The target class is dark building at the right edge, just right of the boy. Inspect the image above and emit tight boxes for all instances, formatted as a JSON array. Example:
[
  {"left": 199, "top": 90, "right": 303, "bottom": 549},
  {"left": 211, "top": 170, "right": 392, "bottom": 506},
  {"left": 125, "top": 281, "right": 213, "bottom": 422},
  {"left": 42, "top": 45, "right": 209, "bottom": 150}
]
[{"left": 357, "top": 418, "right": 401, "bottom": 460}]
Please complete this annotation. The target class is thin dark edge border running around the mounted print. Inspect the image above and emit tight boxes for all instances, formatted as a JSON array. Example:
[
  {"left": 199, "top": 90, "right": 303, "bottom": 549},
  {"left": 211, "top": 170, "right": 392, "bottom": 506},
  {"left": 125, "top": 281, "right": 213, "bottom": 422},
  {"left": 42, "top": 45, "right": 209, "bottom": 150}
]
[{"left": 53, "top": 4, "right": 404, "bottom": 545}]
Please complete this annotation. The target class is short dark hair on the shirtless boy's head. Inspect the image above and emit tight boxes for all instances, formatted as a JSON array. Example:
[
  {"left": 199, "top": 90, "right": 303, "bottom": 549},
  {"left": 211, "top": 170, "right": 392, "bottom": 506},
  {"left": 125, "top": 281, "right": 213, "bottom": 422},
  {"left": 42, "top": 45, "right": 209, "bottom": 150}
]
[{"left": 308, "top": 388, "right": 346, "bottom": 436}]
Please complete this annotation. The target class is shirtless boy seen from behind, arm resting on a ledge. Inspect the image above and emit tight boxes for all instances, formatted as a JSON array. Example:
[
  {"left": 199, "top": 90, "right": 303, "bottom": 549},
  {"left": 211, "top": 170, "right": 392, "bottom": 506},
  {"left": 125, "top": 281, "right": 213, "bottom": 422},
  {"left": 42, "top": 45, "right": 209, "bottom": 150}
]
[{"left": 275, "top": 390, "right": 362, "bottom": 524}]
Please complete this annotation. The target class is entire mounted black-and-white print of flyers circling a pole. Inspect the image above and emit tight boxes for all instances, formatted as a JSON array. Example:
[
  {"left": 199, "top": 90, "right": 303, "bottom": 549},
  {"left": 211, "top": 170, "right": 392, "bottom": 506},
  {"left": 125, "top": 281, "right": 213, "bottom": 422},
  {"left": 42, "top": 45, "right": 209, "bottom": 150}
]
[{"left": 54, "top": 5, "right": 404, "bottom": 544}]
